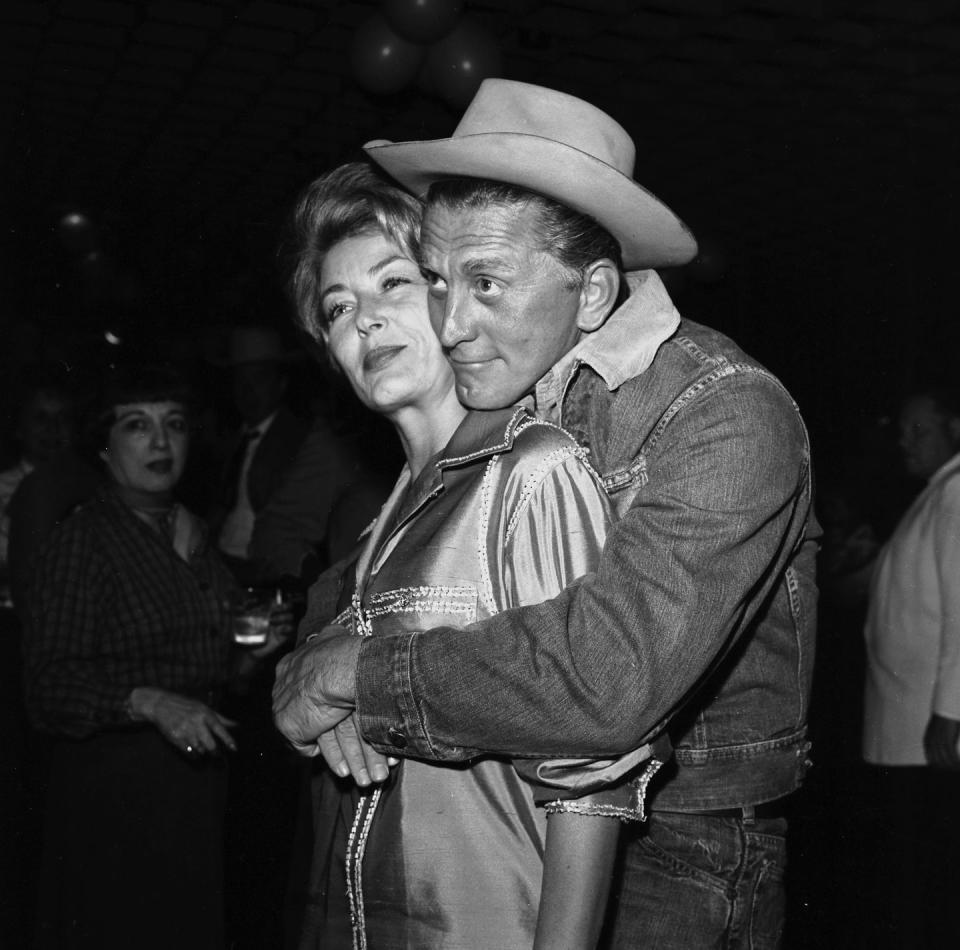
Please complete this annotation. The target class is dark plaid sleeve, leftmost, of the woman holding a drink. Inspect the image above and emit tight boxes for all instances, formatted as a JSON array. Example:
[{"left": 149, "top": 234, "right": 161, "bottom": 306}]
[{"left": 24, "top": 521, "right": 129, "bottom": 738}]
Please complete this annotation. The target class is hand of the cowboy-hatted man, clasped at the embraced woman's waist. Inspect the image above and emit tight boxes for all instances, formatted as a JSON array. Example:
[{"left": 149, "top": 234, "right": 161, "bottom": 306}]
[{"left": 273, "top": 627, "right": 361, "bottom": 756}]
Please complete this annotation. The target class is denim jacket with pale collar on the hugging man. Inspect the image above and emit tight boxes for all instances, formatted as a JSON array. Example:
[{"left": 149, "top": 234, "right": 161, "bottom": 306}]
[{"left": 357, "top": 272, "right": 819, "bottom": 811}]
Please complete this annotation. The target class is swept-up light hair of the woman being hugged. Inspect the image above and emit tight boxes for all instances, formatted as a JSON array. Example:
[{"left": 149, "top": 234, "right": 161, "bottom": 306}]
[{"left": 284, "top": 162, "right": 423, "bottom": 339}]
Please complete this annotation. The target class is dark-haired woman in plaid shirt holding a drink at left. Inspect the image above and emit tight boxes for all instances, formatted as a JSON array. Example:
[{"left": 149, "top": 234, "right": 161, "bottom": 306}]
[{"left": 25, "top": 368, "right": 290, "bottom": 950}]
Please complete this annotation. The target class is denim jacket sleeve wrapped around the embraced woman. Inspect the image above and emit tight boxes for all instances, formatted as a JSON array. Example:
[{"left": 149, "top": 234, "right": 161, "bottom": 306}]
[{"left": 357, "top": 374, "right": 809, "bottom": 761}]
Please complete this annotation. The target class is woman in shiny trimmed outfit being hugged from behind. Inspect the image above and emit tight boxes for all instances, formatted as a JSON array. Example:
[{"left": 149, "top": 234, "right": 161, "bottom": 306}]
[{"left": 292, "top": 165, "right": 660, "bottom": 950}]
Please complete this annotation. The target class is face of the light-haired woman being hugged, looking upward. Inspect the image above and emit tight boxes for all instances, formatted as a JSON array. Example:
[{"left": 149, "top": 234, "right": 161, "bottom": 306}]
[{"left": 320, "top": 232, "right": 453, "bottom": 416}]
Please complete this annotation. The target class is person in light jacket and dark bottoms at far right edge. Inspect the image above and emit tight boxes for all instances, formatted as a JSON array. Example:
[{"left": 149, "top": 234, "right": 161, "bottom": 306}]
[{"left": 863, "top": 387, "right": 960, "bottom": 948}]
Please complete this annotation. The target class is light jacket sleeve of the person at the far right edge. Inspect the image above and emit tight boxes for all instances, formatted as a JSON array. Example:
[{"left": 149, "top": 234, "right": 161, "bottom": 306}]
[{"left": 933, "top": 476, "right": 960, "bottom": 719}]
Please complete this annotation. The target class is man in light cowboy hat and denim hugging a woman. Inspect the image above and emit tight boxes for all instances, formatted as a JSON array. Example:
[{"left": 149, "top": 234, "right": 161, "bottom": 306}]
[{"left": 274, "top": 80, "right": 815, "bottom": 948}]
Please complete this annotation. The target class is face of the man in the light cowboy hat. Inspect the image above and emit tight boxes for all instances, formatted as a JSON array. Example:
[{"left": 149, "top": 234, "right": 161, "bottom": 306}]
[{"left": 421, "top": 204, "right": 581, "bottom": 409}]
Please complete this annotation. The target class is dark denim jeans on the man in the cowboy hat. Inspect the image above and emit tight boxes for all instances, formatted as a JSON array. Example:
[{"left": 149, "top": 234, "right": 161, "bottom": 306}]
[{"left": 607, "top": 812, "right": 787, "bottom": 950}]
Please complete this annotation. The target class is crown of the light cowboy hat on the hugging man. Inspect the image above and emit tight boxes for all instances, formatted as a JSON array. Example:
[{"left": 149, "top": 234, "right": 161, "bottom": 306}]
[{"left": 453, "top": 79, "right": 636, "bottom": 178}]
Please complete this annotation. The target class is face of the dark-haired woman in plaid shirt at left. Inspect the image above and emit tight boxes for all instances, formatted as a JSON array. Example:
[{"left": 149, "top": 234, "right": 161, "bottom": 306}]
[{"left": 100, "top": 402, "right": 189, "bottom": 495}]
